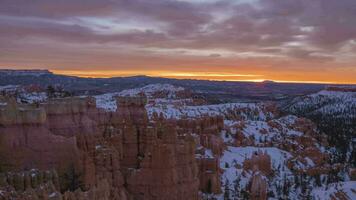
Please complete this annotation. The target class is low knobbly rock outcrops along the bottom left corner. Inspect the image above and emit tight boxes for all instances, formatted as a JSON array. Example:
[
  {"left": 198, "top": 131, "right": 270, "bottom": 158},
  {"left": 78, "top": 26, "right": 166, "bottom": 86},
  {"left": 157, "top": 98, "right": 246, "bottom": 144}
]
[{"left": 0, "top": 169, "right": 118, "bottom": 200}]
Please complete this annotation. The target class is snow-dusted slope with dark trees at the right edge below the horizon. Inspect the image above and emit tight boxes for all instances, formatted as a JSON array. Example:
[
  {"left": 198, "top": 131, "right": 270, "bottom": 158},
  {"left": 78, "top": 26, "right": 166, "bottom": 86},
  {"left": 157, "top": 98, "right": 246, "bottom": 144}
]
[{"left": 284, "top": 87, "right": 356, "bottom": 166}]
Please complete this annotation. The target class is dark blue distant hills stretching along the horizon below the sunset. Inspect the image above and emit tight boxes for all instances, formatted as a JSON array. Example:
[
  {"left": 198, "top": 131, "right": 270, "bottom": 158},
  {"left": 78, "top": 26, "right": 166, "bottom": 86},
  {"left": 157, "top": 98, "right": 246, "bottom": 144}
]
[{"left": 0, "top": 70, "right": 348, "bottom": 103}]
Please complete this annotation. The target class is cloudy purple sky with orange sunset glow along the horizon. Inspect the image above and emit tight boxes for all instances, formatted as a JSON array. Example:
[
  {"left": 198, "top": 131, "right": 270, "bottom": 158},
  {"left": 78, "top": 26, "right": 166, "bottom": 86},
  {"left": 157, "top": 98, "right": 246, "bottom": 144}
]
[{"left": 0, "top": 0, "right": 356, "bottom": 83}]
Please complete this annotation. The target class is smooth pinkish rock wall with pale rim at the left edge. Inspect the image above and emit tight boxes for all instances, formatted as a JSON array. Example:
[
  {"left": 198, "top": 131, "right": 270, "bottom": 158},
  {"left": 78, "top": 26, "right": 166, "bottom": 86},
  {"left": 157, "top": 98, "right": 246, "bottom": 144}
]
[{"left": 0, "top": 100, "right": 79, "bottom": 173}]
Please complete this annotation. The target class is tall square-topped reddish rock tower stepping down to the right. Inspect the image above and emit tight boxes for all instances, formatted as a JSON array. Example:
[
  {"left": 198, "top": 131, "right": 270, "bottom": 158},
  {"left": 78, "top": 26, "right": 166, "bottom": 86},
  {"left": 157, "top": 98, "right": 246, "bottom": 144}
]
[{"left": 118, "top": 97, "right": 199, "bottom": 200}]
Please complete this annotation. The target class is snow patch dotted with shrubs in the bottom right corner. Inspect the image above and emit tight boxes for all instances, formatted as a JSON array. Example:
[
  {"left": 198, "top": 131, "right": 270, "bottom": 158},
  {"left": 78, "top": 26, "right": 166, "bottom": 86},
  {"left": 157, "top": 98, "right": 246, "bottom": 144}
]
[{"left": 312, "top": 181, "right": 356, "bottom": 200}]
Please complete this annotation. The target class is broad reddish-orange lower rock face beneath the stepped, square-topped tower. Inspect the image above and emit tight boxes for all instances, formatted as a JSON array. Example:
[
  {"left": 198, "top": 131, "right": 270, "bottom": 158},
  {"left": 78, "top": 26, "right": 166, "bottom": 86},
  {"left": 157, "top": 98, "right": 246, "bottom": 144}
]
[{"left": 127, "top": 133, "right": 199, "bottom": 200}]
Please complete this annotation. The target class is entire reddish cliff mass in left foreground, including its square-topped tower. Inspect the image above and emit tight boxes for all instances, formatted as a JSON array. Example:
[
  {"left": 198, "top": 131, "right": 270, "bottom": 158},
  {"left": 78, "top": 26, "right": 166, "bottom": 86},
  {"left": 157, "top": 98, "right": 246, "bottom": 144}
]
[{"left": 0, "top": 97, "right": 199, "bottom": 200}]
